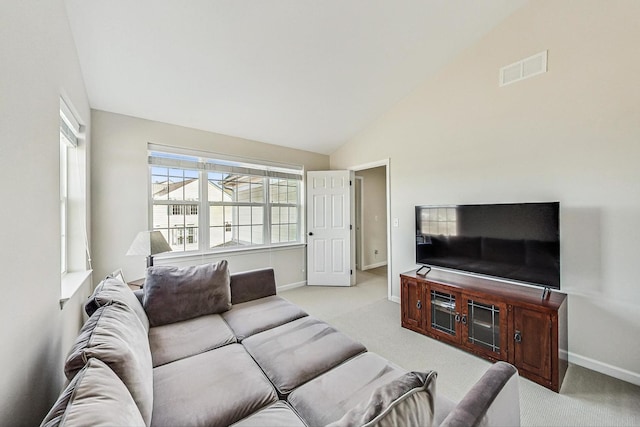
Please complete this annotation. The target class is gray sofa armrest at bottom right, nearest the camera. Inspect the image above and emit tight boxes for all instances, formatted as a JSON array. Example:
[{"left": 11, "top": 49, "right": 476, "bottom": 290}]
[{"left": 441, "top": 362, "right": 520, "bottom": 427}]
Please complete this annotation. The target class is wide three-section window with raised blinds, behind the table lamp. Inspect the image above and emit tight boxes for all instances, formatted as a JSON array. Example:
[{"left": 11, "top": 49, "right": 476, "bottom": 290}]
[{"left": 149, "top": 148, "right": 303, "bottom": 252}]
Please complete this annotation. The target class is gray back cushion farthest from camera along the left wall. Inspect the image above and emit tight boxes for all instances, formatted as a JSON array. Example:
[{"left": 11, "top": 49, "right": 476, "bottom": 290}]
[{"left": 84, "top": 275, "right": 149, "bottom": 331}]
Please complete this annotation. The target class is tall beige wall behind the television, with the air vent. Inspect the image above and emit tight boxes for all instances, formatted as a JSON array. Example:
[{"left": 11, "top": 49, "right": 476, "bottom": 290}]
[{"left": 331, "top": 0, "right": 640, "bottom": 384}]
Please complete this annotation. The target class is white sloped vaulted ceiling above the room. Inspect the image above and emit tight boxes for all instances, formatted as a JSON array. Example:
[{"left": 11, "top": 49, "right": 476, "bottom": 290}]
[{"left": 65, "top": 0, "right": 526, "bottom": 154}]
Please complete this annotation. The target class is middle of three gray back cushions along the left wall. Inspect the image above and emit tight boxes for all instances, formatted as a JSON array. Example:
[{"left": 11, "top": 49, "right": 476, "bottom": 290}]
[{"left": 64, "top": 303, "right": 153, "bottom": 425}]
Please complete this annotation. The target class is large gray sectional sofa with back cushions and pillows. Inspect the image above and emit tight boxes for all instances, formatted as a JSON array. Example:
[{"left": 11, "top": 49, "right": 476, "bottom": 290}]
[{"left": 42, "top": 261, "right": 520, "bottom": 427}]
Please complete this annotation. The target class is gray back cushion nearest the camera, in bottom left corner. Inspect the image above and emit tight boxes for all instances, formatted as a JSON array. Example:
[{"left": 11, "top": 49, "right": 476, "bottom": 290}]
[{"left": 41, "top": 359, "right": 145, "bottom": 427}]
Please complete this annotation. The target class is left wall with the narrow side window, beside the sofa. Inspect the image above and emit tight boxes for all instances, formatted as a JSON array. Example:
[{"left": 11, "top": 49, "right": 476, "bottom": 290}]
[{"left": 0, "top": 0, "right": 90, "bottom": 426}]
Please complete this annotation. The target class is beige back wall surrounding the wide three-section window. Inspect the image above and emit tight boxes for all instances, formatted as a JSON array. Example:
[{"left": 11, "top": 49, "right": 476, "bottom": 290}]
[{"left": 91, "top": 110, "right": 329, "bottom": 286}]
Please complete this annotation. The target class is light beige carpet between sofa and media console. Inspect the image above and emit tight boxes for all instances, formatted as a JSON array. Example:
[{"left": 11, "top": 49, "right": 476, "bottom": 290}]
[{"left": 280, "top": 267, "right": 640, "bottom": 426}]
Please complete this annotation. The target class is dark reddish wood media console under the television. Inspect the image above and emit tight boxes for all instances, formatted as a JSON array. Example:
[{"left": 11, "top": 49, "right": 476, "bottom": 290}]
[{"left": 400, "top": 270, "right": 568, "bottom": 392}]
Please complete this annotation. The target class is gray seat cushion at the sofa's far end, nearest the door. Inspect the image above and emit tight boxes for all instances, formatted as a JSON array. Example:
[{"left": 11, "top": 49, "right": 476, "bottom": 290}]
[{"left": 222, "top": 295, "right": 307, "bottom": 342}]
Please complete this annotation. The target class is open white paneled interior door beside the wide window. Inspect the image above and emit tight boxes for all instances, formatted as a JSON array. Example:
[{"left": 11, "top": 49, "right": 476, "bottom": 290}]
[{"left": 307, "top": 171, "right": 355, "bottom": 286}]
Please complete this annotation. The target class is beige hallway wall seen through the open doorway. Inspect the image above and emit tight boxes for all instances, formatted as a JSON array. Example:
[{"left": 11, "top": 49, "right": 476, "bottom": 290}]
[{"left": 356, "top": 166, "right": 387, "bottom": 270}]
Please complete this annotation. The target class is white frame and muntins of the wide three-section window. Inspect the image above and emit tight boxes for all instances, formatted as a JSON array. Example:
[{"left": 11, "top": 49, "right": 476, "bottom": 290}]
[{"left": 148, "top": 143, "right": 305, "bottom": 256}]
